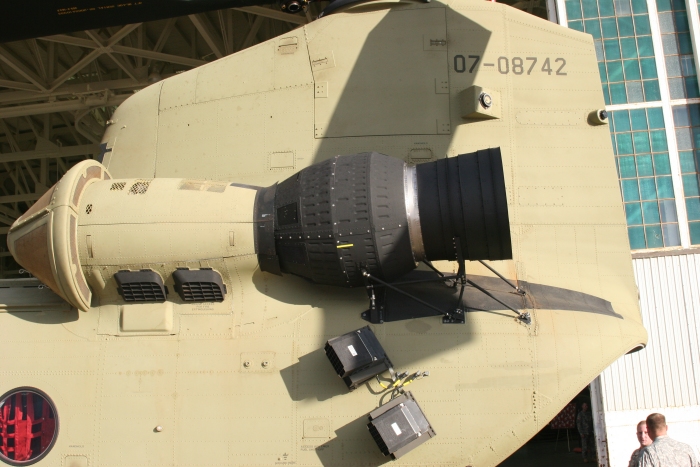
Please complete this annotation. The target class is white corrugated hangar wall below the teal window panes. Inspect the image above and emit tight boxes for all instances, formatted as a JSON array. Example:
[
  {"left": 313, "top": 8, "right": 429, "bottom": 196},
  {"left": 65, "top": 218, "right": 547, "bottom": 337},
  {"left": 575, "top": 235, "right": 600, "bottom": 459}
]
[{"left": 600, "top": 251, "right": 700, "bottom": 467}]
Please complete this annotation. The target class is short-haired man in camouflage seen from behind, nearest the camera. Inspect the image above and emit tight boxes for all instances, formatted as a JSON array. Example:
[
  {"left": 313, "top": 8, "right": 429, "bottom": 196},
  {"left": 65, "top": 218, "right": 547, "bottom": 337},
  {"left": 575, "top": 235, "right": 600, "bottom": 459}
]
[{"left": 639, "top": 413, "right": 700, "bottom": 467}]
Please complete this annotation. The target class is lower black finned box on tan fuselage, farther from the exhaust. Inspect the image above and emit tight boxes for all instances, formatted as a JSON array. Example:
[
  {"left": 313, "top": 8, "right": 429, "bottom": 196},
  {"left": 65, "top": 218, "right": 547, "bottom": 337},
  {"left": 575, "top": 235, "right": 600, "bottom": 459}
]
[{"left": 367, "top": 391, "right": 435, "bottom": 459}]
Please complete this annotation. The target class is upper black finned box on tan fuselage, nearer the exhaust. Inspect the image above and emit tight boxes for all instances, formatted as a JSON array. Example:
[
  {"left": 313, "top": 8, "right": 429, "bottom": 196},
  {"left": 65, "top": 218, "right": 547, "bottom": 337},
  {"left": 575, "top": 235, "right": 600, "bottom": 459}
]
[{"left": 325, "top": 326, "right": 391, "bottom": 391}]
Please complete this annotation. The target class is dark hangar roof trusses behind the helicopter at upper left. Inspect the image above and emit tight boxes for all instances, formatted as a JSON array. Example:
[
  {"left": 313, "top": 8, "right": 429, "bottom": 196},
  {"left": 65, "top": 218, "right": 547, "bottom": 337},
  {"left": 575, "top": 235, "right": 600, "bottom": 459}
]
[{"left": 0, "top": 4, "right": 322, "bottom": 278}]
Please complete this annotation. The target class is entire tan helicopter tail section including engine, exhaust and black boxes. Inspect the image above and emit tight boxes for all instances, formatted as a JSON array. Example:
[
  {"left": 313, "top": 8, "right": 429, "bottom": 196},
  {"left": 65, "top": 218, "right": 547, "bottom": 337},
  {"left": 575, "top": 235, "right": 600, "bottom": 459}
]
[{"left": 0, "top": 0, "right": 647, "bottom": 467}]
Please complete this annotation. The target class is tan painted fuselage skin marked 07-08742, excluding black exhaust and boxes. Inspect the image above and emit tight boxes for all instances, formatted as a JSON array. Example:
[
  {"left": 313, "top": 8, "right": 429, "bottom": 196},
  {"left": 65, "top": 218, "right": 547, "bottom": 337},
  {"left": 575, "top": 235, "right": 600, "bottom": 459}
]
[{"left": 0, "top": 0, "right": 647, "bottom": 467}]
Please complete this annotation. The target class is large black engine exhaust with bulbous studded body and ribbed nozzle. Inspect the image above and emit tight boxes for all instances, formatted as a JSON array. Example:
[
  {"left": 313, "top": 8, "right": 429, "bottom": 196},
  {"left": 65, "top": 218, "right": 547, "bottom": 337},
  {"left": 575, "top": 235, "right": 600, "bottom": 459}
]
[{"left": 255, "top": 148, "right": 512, "bottom": 287}]
